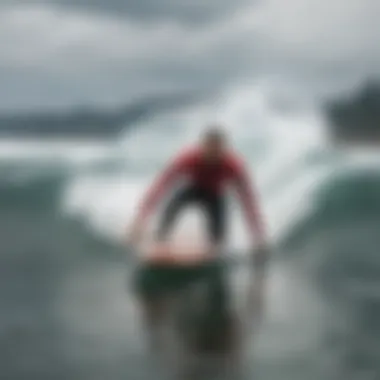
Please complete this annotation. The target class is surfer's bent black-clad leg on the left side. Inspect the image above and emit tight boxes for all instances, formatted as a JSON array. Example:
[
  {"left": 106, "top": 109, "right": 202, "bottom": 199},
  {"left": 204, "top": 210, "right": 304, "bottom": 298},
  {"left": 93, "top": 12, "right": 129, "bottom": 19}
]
[{"left": 156, "top": 188, "right": 197, "bottom": 241}]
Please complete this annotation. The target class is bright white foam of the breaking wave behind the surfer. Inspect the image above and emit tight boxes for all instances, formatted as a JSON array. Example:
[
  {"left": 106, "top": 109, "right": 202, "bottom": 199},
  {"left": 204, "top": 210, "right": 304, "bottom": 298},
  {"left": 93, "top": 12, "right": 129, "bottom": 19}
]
[{"left": 60, "top": 83, "right": 332, "bottom": 247}]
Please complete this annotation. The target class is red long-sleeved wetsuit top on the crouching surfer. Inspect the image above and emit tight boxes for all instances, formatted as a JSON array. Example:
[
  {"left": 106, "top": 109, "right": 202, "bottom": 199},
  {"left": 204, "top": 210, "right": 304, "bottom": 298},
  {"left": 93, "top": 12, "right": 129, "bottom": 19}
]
[{"left": 140, "top": 148, "right": 264, "bottom": 238}]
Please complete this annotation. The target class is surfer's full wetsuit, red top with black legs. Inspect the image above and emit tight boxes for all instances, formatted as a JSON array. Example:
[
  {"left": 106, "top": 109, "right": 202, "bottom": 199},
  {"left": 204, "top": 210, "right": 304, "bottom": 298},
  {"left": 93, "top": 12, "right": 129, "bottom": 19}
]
[{"left": 141, "top": 148, "right": 263, "bottom": 243}]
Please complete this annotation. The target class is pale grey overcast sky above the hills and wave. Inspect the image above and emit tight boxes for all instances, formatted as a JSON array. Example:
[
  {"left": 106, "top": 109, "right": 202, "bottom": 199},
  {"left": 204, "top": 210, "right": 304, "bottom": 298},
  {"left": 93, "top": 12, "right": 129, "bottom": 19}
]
[{"left": 0, "top": 0, "right": 380, "bottom": 110}]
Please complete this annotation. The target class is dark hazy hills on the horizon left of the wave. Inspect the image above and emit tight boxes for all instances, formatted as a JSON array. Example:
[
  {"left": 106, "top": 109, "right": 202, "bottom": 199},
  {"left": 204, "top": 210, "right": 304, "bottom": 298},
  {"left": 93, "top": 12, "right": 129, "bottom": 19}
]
[{"left": 0, "top": 94, "right": 196, "bottom": 140}]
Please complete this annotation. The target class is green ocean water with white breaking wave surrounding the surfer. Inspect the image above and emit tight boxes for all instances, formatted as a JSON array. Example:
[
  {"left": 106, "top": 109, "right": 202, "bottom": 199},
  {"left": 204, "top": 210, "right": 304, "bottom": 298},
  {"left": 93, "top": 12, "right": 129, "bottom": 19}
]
[{"left": 0, "top": 86, "right": 380, "bottom": 380}]
